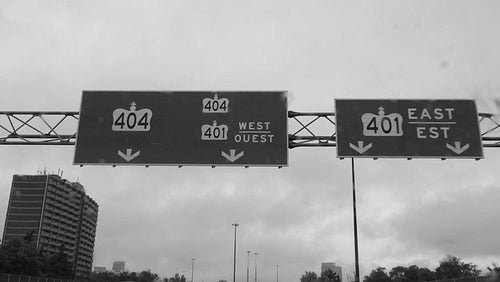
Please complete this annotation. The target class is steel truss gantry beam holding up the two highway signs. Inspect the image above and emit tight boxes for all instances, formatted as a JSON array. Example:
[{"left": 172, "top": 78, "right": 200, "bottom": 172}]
[{"left": 0, "top": 111, "right": 500, "bottom": 148}]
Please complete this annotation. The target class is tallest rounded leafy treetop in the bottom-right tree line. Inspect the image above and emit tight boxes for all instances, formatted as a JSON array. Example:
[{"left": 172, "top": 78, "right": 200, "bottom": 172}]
[{"left": 436, "top": 255, "right": 481, "bottom": 279}]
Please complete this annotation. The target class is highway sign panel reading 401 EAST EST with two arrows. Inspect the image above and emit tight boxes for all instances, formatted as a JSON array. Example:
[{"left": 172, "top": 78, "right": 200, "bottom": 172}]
[{"left": 335, "top": 99, "right": 483, "bottom": 159}]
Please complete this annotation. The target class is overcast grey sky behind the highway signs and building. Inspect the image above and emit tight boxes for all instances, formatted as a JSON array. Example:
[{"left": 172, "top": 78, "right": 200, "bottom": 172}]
[{"left": 0, "top": 0, "right": 500, "bottom": 282}]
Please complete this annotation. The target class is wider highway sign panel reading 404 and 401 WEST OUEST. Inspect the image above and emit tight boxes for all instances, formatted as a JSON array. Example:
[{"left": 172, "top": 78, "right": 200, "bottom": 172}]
[{"left": 74, "top": 91, "right": 288, "bottom": 166}]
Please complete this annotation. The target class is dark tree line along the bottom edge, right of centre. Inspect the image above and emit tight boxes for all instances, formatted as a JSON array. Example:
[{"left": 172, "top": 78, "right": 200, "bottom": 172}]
[{"left": 300, "top": 255, "right": 500, "bottom": 282}]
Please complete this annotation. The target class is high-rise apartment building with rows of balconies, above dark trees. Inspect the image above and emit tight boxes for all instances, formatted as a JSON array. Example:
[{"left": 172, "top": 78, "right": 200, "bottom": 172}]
[{"left": 2, "top": 174, "right": 99, "bottom": 276}]
